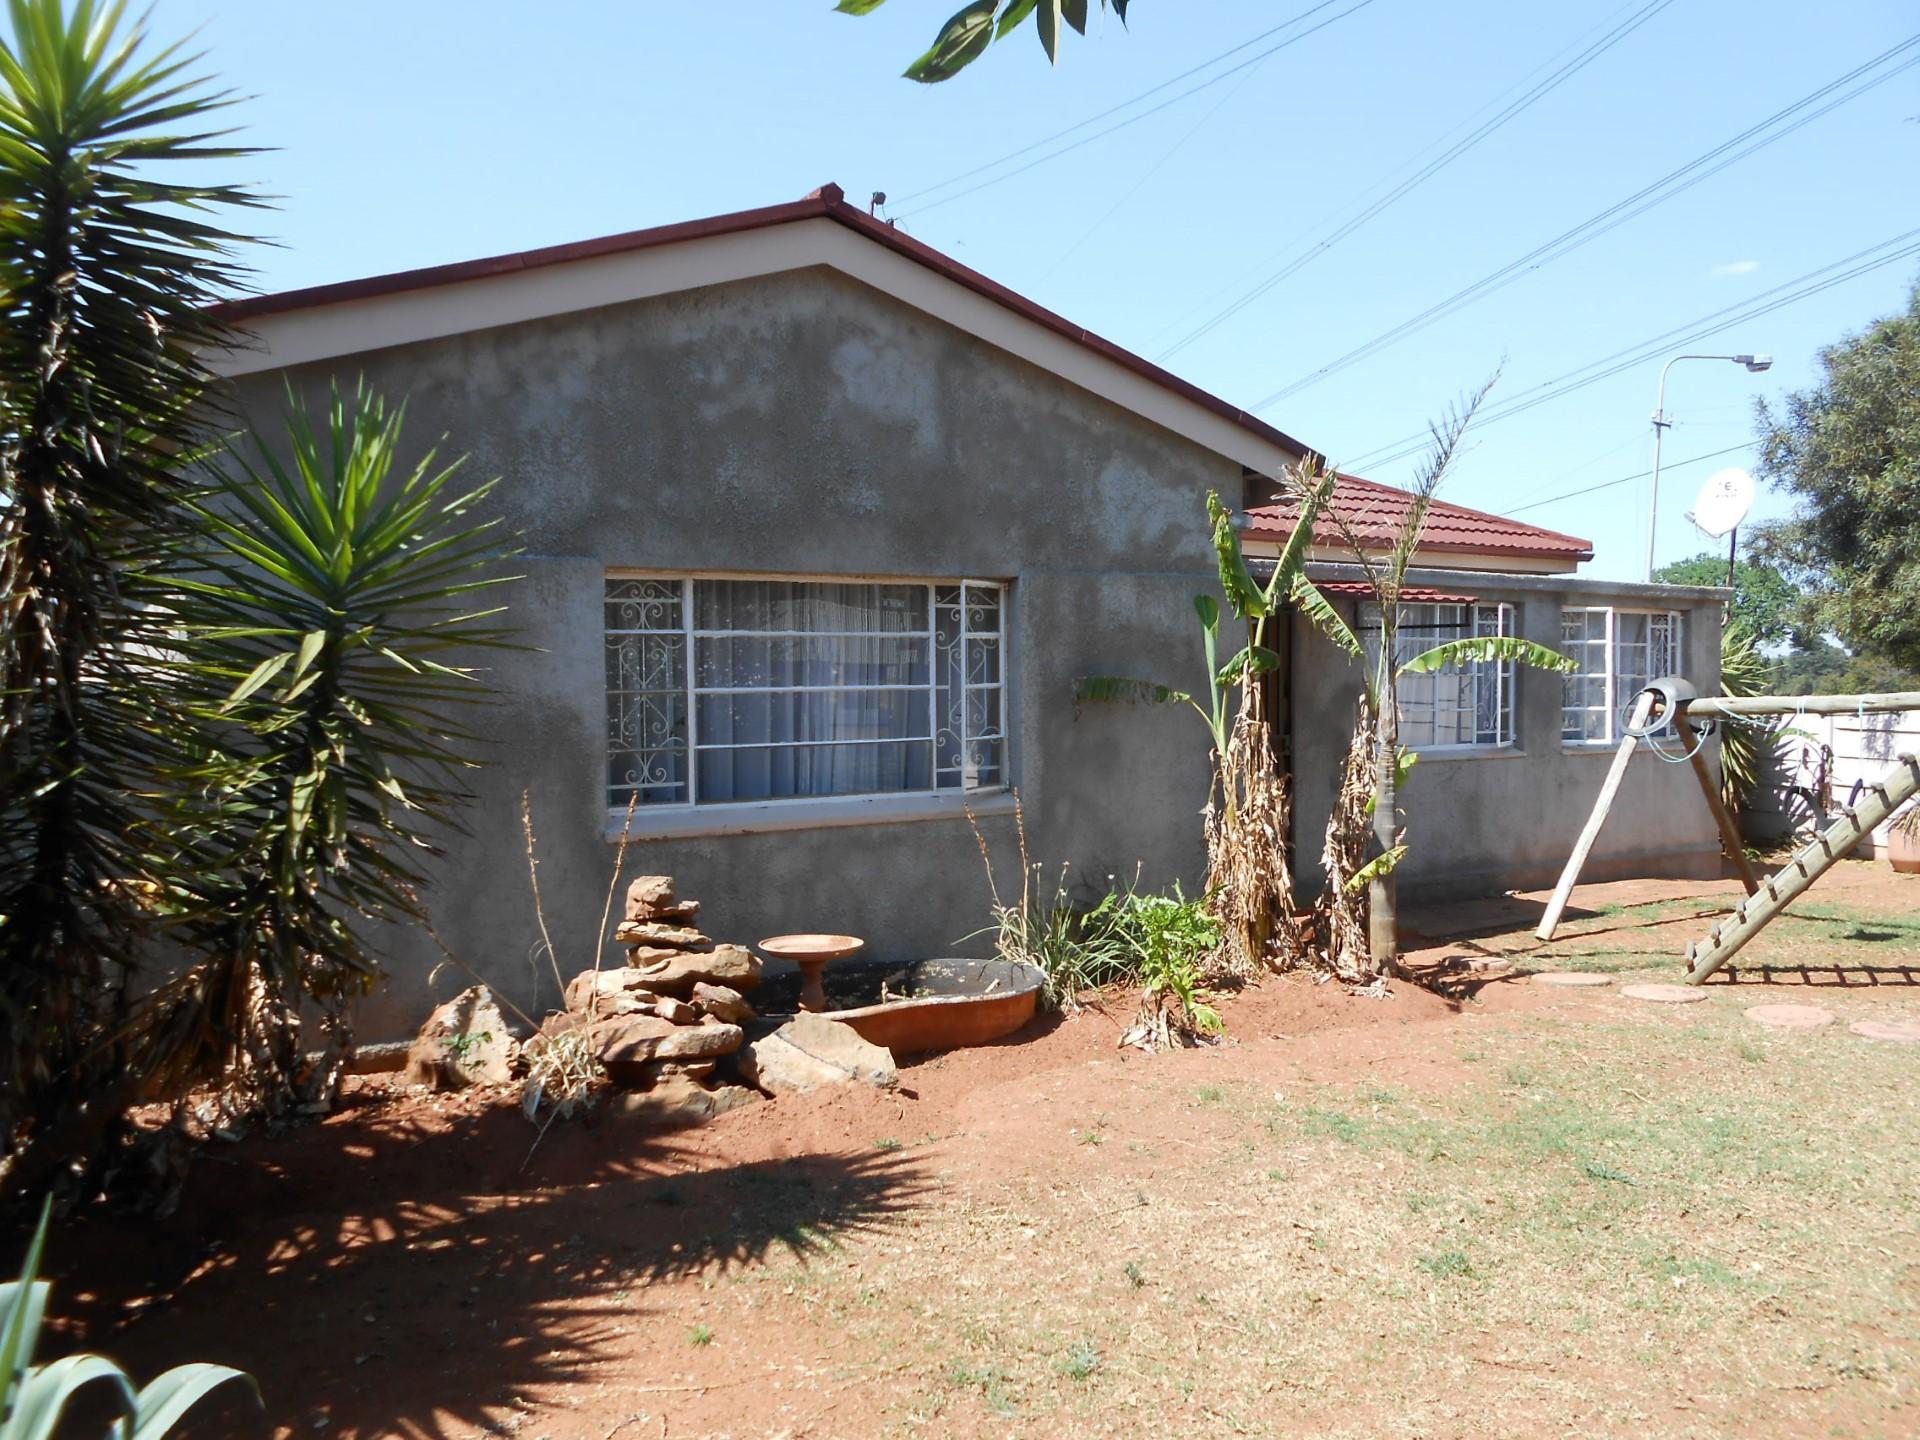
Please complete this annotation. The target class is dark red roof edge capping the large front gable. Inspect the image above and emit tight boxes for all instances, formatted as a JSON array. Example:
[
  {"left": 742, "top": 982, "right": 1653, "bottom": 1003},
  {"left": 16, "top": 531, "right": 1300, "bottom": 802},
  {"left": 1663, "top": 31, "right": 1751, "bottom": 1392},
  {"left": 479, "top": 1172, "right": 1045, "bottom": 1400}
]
[{"left": 211, "top": 184, "right": 1315, "bottom": 455}]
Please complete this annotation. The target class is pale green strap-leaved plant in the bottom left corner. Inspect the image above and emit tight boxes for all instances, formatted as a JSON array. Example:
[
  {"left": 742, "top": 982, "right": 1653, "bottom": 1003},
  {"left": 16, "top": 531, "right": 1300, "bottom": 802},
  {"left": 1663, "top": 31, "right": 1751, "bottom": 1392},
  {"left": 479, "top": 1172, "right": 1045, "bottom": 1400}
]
[{"left": 0, "top": 1202, "right": 259, "bottom": 1440}]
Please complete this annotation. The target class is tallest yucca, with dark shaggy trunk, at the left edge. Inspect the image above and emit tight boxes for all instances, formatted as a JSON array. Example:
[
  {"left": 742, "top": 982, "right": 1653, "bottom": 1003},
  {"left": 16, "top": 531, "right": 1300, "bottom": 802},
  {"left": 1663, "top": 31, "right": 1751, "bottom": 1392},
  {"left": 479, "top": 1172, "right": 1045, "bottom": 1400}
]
[{"left": 0, "top": 0, "right": 259, "bottom": 1188}]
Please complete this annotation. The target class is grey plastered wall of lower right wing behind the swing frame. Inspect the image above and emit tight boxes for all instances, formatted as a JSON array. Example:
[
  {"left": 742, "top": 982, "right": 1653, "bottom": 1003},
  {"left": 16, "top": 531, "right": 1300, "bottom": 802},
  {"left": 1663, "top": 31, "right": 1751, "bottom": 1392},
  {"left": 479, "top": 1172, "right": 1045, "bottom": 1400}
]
[{"left": 1294, "top": 570, "right": 1720, "bottom": 900}]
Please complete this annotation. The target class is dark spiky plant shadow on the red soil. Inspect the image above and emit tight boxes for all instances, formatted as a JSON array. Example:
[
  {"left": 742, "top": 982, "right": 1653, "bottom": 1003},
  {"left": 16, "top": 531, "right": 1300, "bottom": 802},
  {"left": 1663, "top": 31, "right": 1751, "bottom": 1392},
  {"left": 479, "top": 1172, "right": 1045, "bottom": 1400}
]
[{"left": 33, "top": 1106, "right": 925, "bottom": 1438}]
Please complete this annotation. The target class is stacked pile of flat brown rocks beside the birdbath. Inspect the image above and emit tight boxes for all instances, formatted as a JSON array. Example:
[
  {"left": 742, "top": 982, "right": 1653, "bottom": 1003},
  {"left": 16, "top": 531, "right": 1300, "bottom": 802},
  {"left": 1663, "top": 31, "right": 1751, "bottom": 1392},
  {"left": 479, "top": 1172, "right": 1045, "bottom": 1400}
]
[{"left": 541, "top": 876, "right": 760, "bottom": 1123}]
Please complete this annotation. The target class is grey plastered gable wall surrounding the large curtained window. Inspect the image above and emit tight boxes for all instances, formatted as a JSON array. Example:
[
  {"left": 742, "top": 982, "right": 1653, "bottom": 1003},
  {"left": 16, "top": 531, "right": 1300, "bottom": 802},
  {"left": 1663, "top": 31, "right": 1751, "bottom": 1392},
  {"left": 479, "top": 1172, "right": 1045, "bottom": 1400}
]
[{"left": 214, "top": 271, "right": 1240, "bottom": 1039}]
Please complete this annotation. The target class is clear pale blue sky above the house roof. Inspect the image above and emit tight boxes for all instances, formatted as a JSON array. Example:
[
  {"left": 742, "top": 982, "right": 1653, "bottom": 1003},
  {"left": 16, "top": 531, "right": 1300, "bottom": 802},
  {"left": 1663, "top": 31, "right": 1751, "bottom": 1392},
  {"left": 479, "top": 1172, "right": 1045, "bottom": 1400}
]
[{"left": 183, "top": 0, "right": 1920, "bottom": 578}]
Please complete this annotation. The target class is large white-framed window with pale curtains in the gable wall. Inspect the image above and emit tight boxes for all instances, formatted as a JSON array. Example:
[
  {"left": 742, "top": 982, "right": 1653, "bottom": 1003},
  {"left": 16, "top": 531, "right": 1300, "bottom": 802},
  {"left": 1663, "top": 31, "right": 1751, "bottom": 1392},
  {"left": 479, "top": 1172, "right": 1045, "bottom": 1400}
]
[{"left": 607, "top": 578, "right": 1006, "bottom": 810}]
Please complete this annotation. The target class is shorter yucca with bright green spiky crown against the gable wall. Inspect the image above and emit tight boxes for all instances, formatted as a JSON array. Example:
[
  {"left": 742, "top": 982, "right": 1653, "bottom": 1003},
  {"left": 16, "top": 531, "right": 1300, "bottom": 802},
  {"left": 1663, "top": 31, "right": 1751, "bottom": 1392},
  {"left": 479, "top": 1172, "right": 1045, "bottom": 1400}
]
[{"left": 134, "top": 388, "right": 509, "bottom": 1110}]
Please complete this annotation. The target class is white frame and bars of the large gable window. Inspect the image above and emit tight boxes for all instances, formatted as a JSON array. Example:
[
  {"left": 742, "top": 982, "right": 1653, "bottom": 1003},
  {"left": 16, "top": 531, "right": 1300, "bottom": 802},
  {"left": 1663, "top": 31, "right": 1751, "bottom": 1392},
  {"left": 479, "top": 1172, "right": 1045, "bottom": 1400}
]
[{"left": 601, "top": 568, "right": 1012, "bottom": 833}]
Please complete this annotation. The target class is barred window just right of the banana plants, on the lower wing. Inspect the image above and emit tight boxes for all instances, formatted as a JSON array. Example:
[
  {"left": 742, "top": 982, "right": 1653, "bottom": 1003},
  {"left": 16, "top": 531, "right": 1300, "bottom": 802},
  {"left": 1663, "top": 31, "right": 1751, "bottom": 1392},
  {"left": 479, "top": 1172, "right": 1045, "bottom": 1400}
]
[{"left": 1359, "top": 605, "right": 1515, "bottom": 751}]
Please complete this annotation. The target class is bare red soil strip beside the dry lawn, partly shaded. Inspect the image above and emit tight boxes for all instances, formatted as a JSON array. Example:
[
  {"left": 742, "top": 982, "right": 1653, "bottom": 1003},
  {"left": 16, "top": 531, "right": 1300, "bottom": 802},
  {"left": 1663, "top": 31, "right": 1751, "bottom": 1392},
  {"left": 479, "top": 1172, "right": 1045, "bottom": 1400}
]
[{"left": 33, "top": 867, "right": 1905, "bottom": 1440}]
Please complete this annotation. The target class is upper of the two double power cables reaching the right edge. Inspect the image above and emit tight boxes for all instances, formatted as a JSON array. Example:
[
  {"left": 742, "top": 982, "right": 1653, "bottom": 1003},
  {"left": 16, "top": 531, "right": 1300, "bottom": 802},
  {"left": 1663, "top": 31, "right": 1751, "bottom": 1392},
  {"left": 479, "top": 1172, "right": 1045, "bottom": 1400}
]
[{"left": 1250, "top": 35, "right": 1920, "bottom": 411}]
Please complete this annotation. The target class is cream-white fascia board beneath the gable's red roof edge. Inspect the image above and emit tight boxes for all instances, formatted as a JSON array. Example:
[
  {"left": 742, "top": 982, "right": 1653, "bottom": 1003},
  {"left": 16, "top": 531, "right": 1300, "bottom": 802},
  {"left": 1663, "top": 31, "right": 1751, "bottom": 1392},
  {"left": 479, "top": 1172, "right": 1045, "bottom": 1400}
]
[{"left": 211, "top": 219, "right": 1296, "bottom": 474}]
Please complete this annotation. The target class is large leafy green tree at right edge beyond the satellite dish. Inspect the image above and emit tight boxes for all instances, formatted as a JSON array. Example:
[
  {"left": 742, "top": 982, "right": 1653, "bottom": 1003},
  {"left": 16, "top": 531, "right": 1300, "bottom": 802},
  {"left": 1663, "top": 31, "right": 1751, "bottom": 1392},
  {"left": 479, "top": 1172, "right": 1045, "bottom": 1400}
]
[{"left": 1755, "top": 284, "right": 1920, "bottom": 670}]
